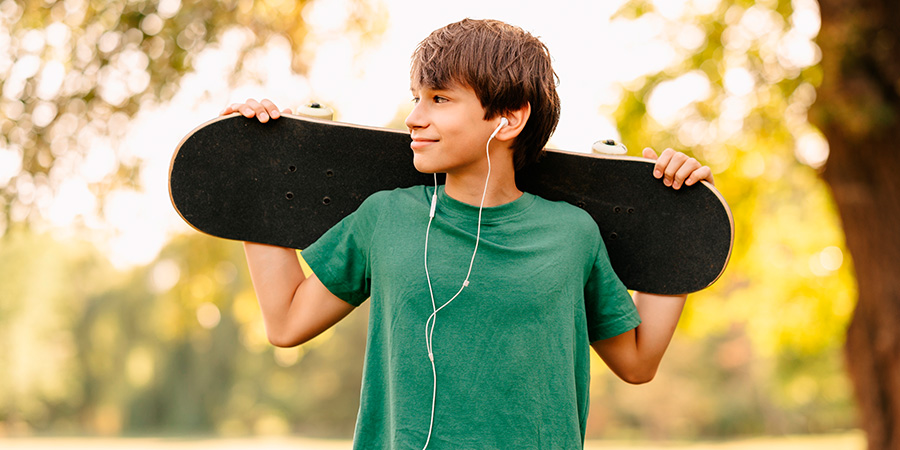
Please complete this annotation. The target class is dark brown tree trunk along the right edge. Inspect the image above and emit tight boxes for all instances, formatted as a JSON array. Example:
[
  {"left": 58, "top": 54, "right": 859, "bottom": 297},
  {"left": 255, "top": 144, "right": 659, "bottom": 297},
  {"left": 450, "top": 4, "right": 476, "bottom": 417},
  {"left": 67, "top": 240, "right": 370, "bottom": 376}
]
[{"left": 810, "top": 0, "right": 900, "bottom": 450}]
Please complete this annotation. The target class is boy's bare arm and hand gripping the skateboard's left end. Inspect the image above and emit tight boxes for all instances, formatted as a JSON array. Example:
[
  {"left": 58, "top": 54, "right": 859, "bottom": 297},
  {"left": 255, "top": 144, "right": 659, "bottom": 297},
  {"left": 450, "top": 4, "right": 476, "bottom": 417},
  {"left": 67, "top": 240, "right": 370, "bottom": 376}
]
[{"left": 222, "top": 99, "right": 354, "bottom": 347}]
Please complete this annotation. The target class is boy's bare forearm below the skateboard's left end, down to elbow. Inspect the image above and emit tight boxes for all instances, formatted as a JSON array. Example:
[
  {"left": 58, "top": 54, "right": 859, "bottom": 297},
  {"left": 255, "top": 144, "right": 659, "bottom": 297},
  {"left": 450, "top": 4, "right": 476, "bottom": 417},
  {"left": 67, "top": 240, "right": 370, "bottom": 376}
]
[{"left": 244, "top": 242, "right": 306, "bottom": 334}]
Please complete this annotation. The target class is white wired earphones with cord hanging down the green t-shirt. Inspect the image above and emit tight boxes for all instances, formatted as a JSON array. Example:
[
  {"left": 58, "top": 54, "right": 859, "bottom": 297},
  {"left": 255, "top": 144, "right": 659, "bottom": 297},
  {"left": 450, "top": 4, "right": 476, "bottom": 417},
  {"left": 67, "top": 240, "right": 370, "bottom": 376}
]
[{"left": 422, "top": 117, "right": 509, "bottom": 450}]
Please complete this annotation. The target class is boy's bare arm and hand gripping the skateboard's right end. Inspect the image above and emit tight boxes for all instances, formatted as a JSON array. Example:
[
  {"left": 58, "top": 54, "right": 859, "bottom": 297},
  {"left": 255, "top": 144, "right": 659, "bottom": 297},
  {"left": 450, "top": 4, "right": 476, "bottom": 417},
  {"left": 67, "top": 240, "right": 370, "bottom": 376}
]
[{"left": 591, "top": 148, "right": 713, "bottom": 384}]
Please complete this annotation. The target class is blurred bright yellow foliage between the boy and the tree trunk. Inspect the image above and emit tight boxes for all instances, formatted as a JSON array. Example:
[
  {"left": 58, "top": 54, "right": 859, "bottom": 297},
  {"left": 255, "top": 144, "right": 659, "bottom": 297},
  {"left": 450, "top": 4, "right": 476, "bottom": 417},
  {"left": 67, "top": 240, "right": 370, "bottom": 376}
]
[{"left": 591, "top": 0, "right": 856, "bottom": 438}]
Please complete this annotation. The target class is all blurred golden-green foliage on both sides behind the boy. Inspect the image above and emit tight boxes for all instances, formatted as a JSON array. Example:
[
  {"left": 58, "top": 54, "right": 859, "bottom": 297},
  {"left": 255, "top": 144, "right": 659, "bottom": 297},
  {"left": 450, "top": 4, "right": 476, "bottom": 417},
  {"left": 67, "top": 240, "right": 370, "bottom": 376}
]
[{"left": 0, "top": 0, "right": 855, "bottom": 439}]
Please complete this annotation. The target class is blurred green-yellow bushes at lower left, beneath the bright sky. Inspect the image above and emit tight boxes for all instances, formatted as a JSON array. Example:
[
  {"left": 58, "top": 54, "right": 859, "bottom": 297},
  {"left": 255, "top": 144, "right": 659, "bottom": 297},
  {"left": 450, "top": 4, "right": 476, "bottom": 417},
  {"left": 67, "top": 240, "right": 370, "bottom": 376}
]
[{"left": 0, "top": 228, "right": 367, "bottom": 436}]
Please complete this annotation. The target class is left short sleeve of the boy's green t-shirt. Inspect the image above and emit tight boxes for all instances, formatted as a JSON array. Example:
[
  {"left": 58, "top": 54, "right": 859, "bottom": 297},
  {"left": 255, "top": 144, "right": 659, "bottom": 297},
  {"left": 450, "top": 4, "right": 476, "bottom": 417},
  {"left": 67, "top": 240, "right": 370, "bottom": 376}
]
[{"left": 300, "top": 193, "right": 384, "bottom": 306}]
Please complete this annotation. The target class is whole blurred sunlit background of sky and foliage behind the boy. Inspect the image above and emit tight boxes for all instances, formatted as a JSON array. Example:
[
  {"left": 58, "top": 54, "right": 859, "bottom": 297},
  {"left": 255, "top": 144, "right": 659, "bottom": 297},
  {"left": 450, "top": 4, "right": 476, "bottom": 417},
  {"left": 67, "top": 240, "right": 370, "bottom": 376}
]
[{"left": 0, "top": 0, "right": 856, "bottom": 448}]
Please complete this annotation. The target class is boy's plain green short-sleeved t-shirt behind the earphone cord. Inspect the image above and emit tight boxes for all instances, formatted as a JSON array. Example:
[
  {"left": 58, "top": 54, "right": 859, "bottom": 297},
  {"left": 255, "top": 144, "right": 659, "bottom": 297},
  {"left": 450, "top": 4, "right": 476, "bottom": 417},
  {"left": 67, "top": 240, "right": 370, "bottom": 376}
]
[{"left": 303, "top": 186, "right": 640, "bottom": 450}]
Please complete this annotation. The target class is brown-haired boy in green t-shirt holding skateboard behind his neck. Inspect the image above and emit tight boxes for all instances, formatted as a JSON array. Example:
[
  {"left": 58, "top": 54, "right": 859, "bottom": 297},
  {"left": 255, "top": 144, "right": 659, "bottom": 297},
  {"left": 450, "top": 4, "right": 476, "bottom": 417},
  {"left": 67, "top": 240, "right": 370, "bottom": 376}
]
[{"left": 223, "top": 19, "right": 712, "bottom": 449}]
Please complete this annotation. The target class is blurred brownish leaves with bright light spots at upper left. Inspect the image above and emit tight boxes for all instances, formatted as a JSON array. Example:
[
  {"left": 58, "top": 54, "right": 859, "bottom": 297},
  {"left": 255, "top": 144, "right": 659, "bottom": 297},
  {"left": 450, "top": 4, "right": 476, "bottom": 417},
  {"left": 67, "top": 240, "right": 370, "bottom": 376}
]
[{"left": 0, "top": 0, "right": 384, "bottom": 235}]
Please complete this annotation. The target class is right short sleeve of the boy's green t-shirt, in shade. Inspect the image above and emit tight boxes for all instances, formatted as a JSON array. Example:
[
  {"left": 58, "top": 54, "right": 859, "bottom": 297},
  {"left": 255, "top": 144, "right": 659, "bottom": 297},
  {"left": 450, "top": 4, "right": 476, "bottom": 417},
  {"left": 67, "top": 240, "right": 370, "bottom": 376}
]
[{"left": 584, "top": 239, "right": 641, "bottom": 342}]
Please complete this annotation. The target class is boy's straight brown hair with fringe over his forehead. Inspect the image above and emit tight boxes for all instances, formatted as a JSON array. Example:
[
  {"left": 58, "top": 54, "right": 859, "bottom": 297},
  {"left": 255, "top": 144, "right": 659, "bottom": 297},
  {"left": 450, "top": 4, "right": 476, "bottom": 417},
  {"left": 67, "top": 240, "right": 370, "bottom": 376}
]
[{"left": 410, "top": 19, "right": 560, "bottom": 170}]
